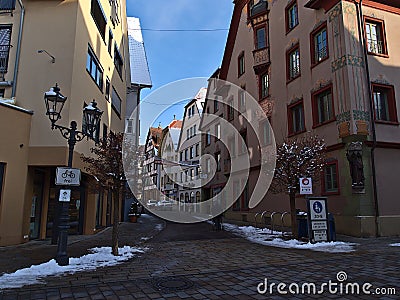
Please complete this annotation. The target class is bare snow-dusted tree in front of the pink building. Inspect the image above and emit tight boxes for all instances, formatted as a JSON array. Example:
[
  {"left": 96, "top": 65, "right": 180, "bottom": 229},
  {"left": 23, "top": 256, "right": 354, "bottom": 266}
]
[{"left": 271, "top": 135, "right": 326, "bottom": 238}]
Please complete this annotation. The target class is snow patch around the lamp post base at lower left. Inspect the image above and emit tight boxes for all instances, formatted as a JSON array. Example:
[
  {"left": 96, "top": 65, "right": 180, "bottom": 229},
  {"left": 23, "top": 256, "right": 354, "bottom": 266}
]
[{"left": 0, "top": 246, "right": 146, "bottom": 290}]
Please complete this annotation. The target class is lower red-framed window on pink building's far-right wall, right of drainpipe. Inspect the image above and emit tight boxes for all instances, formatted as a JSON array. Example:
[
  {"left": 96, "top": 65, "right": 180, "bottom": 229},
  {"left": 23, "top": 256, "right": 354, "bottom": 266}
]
[{"left": 372, "top": 83, "right": 397, "bottom": 123}]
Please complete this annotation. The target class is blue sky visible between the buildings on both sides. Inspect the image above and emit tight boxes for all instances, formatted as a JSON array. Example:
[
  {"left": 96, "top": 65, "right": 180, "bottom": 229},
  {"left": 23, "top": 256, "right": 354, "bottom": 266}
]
[{"left": 126, "top": 0, "right": 233, "bottom": 141}]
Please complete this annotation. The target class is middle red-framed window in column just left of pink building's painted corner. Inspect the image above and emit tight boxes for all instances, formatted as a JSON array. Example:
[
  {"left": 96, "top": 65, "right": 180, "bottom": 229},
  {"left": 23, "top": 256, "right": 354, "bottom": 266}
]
[{"left": 312, "top": 86, "right": 335, "bottom": 126}]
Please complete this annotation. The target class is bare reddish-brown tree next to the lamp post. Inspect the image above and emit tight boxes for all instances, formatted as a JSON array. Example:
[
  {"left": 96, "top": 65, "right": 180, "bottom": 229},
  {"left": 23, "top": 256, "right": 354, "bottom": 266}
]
[{"left": 82, "top": 132, "right": 126, "bottom": 255}]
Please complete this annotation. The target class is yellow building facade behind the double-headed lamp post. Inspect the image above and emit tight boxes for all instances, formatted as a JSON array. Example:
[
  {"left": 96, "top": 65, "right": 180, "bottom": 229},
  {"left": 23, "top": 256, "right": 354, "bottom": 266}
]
[{"left": 0, "top": 0, "right": 130, "bottom": 246}]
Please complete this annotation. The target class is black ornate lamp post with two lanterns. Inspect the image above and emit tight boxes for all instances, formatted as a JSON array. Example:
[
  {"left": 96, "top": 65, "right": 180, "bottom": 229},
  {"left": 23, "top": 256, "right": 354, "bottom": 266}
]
[{"left": 44, "top": 84, "right": 103, "bottom": 266}]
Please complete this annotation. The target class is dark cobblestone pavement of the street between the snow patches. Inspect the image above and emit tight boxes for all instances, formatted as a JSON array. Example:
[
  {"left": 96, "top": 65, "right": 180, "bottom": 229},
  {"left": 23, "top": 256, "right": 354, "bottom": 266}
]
[{"left": 0, "top": 219, "right": 400, "bottom": 300}]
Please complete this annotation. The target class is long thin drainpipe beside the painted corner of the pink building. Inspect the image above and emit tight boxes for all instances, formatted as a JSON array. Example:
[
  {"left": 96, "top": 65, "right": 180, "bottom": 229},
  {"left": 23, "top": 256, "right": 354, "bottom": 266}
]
[{"left": 354, "top": 0, "right": 379, "bottom": 237}]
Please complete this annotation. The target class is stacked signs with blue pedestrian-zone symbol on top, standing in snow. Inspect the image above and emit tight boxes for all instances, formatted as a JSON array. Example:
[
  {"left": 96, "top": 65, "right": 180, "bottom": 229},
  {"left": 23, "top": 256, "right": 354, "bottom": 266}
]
[{"left": 307, "top": 197, "right": 329, "bottom": 242}]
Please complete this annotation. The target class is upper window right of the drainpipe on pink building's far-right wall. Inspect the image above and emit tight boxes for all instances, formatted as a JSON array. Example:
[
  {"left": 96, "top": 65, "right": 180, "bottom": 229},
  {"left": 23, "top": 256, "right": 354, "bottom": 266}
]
[{"left": 365, "top": 17, "right": 387, "bottom": 55}]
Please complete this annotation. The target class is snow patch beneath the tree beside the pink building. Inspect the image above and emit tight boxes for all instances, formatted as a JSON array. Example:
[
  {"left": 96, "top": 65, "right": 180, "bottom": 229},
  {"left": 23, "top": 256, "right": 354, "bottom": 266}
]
[{"left": 223, "top": 223, "right": 356, "bottom": 253}]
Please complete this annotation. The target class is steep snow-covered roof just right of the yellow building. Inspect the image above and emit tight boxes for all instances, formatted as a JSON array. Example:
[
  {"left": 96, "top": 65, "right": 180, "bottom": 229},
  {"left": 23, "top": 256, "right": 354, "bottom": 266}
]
[{"left": 127, "top": 17, "right": 152, "bottom": 87}]
